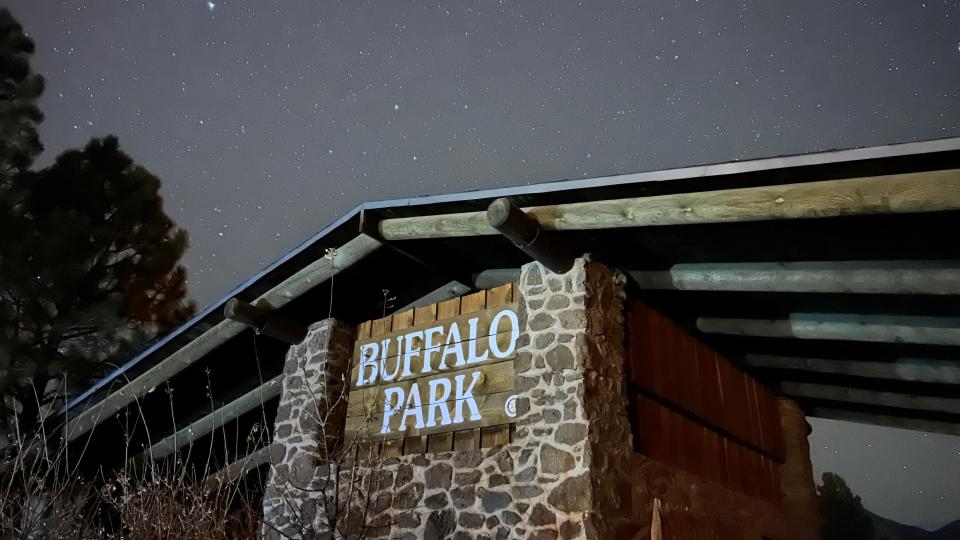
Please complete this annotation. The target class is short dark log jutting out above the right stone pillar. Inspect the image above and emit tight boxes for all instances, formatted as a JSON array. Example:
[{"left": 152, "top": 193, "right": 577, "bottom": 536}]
[{"left": 487, "top": 197, "right": 576, "bottom": 274}]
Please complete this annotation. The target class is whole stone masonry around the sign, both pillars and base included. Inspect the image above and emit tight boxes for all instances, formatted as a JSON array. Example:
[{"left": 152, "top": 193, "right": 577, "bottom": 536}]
[{"left": 264, "top": 258, "right": 785, "bottom": 540}]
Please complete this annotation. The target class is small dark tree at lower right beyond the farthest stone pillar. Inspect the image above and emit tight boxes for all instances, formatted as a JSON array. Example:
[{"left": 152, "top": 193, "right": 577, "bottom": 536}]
[{"left": 817, "top": 472, "right": 874, "bottom": 540}]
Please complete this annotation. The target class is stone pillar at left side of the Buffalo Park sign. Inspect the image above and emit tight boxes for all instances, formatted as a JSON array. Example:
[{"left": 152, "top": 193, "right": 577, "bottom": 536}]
[{"left": 263, "top": 319, "right": 355, "bottom": 538}]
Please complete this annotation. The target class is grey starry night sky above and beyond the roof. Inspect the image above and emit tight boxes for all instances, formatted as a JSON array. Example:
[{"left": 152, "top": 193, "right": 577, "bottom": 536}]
[{"left": 10, "top": 0, "right": 960, "bottom": 527}]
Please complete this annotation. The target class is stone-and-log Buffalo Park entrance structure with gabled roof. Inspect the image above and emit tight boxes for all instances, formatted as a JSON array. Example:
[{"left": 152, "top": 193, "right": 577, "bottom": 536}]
[{"left": 58, "top": 139, "right": 960, "bottom": 540}]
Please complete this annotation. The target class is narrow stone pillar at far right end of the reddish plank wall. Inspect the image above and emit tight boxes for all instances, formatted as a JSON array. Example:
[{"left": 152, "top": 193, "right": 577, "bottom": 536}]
[{"left": 777, "top": 398, "right": 820, "bottom": 540}]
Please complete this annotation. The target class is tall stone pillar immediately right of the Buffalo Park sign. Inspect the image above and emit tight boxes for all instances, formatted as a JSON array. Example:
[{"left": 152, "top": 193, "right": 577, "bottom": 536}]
[{"left": 511, "top": 258, "right": 631, "bottom": 538}]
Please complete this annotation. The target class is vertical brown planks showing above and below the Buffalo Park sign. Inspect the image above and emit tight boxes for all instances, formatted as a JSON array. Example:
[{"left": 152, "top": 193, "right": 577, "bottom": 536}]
[{"left": 357, "top": 283, "right": 519, "bottom": 459}]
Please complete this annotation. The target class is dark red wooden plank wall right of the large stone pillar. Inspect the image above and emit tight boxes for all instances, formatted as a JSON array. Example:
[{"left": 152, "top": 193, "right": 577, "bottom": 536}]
[{"left": 628, "top": 300, "right": 784, "bottom": 502}]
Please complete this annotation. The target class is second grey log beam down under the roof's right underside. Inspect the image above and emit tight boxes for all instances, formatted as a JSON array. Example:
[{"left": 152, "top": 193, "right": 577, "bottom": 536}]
[{"left": 697, "top": 313, "right": 960, "bottom": 346}]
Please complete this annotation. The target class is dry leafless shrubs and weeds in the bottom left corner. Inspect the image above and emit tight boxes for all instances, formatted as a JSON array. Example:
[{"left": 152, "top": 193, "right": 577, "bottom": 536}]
[{"left": 0, "top": 392, "right": 260, "bottom": 540}]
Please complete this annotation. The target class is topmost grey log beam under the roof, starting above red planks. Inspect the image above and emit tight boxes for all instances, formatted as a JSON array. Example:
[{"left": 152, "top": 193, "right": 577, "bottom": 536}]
[{"left": 628, "top": 261, "right": 960, "bottom": 295}]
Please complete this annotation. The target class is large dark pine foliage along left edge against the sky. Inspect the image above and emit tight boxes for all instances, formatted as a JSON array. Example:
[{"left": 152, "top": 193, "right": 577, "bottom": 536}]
[{"left": 0, "top": 9, "right": 194, "bottom": 438}]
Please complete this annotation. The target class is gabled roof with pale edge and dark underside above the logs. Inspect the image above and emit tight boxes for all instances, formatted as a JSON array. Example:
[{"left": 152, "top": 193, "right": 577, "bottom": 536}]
[{"left": 58, "top": 138, "right": 960, "bottom": 474}]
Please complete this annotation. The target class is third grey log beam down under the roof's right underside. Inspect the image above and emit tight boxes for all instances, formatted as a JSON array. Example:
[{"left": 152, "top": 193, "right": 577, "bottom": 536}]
[{"left": 743, "top": 354, "right": 960, "bottom": 384}]
